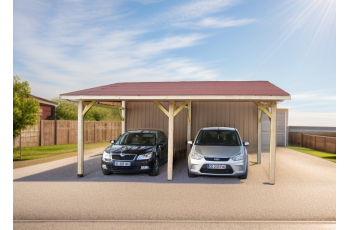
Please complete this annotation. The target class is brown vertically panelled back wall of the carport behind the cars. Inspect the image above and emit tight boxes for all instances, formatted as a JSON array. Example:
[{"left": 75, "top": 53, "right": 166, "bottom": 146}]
[{"left": 125, "top": 102, "right": 258, "bottom": 153}]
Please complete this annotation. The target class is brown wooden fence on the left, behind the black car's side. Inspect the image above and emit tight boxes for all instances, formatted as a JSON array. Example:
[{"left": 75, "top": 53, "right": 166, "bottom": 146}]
[{"left": 13, "top": 120, "right": 121, "bottom": 148}]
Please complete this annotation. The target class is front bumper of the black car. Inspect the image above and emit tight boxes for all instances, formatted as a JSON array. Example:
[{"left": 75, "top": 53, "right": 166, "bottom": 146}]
[{"left": 101, "top": 157, "right": 154, "bottom": 173}]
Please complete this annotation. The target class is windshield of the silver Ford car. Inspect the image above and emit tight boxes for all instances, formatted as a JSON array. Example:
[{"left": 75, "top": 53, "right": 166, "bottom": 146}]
[{"left": 195, "top": 130, "right": 242, "bottom": 146}]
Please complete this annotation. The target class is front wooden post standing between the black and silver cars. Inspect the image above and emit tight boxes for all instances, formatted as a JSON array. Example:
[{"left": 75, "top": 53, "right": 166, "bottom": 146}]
[{"left": 168, "top": 101, "right": 174, "bottom": 180}]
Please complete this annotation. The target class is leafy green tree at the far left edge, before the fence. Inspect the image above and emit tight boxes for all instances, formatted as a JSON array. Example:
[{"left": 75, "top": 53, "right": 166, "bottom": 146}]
[{"left": 13, "top": 75, "right": 40, "bottom": 138}]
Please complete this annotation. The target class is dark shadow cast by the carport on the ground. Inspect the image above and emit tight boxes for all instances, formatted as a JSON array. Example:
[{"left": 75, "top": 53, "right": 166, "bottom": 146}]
[{"left": 14, "top": 154, "right": 242, "bottom": 184}]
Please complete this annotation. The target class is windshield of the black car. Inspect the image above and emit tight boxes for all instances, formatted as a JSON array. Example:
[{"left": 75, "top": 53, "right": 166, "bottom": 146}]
[{"left": 116, "top": 132, "right": 156, "bottom": 146}]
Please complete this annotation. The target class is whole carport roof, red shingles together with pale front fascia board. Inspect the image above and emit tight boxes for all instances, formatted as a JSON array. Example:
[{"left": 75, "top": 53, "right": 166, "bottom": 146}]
[{"left": 61, "top": 81, "right": 290, "bottom": 101}]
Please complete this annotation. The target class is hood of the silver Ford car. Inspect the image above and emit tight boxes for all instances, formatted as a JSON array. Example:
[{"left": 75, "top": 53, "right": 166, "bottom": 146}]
[{"left": 193, "top": 145, "right": 243, "bottom": 157}]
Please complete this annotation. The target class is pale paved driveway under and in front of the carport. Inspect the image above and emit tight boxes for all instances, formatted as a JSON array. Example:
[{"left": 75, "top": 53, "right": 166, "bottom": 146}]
[{"left": 13, "top": 148, "right": 336, "bottom": 221}]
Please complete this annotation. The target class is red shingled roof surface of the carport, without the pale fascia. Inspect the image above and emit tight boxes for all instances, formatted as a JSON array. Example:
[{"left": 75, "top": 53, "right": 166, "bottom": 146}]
[{"left": 61, "top": 81, "right": 290, "bottom": 96}]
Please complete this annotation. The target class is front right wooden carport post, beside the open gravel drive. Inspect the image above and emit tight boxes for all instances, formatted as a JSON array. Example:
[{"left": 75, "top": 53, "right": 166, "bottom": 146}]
[{"left": 269, "top": 101, "right": 277, "bottom": 184}]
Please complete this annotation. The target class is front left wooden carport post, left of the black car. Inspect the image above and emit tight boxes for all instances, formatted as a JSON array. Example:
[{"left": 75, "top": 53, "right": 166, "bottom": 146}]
[{"left": 78, "top": 101, "right": 84, "bottom": 177}]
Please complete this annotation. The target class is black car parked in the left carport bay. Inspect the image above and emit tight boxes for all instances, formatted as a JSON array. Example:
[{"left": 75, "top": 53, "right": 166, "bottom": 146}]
[{"left": 101, "top": 130, "right": 168, "bottom": 176}]
